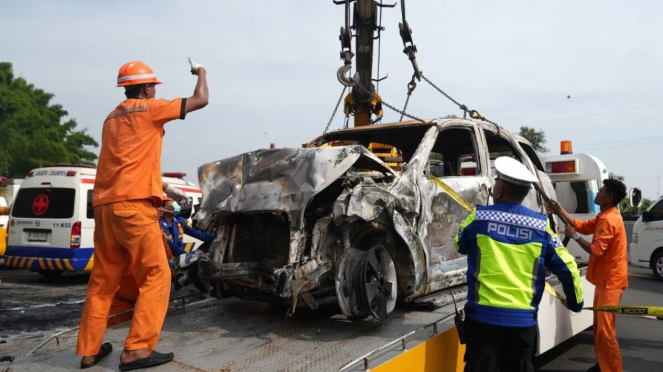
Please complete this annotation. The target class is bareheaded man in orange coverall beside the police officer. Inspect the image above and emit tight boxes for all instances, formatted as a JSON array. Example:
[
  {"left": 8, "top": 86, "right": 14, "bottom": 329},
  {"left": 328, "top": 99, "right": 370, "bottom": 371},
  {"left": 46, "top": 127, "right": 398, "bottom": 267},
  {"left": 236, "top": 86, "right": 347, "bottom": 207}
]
[{"left": 549, "top": 179, "right": 628, "bottom": 372}]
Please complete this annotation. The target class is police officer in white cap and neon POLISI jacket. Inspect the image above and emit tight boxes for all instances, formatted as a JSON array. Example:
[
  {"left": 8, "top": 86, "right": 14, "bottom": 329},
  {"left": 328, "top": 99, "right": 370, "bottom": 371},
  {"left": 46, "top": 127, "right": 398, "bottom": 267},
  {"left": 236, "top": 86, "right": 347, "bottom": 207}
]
[{"left": 455, "top": 157, "right": 583, "bottom": 372}]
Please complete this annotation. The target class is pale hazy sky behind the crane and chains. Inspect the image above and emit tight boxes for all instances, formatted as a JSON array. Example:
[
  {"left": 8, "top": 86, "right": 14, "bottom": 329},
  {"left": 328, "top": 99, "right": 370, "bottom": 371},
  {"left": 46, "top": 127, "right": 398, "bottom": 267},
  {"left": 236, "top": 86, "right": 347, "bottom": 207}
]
[{"left": 0, "top": 0, "right": 663, "bottom": 198}]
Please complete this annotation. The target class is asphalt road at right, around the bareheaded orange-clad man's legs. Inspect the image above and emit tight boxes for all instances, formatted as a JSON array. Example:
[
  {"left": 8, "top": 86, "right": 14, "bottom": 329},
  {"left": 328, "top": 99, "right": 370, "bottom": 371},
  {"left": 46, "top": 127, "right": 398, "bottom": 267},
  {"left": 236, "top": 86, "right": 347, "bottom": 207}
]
[{"left": 539, "top": 266, "right": 663, "bottom": 372}]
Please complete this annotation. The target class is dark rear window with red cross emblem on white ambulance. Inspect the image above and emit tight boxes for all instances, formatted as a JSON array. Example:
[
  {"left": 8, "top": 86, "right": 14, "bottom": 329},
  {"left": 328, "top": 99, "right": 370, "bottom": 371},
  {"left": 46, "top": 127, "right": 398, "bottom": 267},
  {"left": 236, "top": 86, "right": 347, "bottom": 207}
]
[{"left": 12, "top": 187, "right": 76, "bottom": 219}]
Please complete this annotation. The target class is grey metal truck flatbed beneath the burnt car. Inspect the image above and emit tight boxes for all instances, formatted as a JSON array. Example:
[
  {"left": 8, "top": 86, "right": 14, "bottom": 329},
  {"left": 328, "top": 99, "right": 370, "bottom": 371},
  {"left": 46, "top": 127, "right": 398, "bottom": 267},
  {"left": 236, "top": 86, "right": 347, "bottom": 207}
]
[{"left": 11, "top": 298, "right": 463, "bottom": 372}]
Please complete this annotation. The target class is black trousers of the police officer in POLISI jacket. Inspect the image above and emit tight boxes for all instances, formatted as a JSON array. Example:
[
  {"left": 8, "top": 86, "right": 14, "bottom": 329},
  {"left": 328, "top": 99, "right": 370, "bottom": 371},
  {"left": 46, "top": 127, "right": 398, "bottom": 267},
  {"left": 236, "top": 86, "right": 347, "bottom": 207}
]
[{"left": 464, "top": 318, "right": 536, "bottom": 372}]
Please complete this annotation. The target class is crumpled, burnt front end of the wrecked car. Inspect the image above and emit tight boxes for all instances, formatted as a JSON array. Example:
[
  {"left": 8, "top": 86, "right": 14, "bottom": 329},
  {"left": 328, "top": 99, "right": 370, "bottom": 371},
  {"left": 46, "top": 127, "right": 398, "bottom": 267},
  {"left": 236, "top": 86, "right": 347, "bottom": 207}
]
[{"left": 196, "top": 146, "right": 424, "bottom": 318}]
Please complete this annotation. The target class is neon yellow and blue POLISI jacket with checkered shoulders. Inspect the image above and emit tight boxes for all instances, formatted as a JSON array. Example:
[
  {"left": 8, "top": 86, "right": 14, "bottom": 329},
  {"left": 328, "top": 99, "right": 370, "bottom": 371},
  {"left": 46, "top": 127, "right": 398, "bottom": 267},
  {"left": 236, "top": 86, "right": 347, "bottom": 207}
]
[{"left": 456, "top": 203, "right": 582, "bottom": 327}]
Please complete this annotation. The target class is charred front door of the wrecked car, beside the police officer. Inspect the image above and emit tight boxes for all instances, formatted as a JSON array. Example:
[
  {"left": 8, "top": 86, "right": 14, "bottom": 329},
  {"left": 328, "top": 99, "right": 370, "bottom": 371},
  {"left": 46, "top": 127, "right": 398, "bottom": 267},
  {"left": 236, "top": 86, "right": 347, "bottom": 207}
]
[{"left": 419, "top": 120, "right": 493, "bottom": 292}]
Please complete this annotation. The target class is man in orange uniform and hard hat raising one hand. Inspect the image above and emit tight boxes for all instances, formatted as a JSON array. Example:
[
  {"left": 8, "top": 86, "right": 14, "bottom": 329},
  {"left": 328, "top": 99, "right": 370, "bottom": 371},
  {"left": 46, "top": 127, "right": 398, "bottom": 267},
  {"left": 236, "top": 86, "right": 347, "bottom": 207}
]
[{"left": 76, "top": 58, "right": 209, "bottom": 371}]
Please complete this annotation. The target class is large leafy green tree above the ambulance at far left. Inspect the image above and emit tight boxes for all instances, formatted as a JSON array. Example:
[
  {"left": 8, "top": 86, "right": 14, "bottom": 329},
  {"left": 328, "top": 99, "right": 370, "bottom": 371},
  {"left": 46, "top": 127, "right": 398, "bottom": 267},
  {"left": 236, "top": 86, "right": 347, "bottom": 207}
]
[{"left": 0, "top": 62, "right": 99, "bottom": 178}]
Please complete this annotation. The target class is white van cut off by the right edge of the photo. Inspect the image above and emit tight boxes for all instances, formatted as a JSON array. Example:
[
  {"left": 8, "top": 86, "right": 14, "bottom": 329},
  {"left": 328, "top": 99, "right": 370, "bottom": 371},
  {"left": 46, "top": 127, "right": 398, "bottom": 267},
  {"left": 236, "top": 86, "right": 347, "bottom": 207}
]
[{"left": 630, "top": 198, "right": 663, "bottom": 281}]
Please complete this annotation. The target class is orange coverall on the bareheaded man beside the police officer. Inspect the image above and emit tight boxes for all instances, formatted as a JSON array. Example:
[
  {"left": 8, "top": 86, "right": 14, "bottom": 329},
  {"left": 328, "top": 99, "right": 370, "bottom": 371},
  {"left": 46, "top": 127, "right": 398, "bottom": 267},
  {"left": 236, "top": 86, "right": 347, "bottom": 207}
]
[{"left": 575, "top": 207, "right": 628, "bottom": 372}]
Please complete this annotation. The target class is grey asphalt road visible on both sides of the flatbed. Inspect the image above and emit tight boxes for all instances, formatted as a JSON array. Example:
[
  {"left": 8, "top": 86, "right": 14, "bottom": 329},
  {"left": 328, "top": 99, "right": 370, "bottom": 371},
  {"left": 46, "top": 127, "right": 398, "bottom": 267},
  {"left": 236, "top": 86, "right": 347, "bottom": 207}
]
[{"left": 0, "top": 267, "right": 663, "bottom": 372}]
